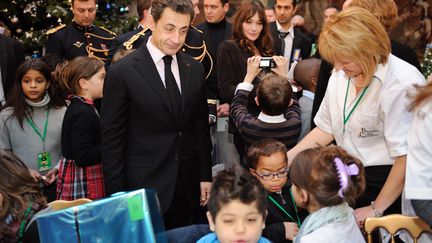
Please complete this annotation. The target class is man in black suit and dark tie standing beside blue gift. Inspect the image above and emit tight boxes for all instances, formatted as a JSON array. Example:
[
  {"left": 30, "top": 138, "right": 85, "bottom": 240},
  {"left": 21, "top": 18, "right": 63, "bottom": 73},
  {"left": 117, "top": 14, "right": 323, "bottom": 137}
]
[{"left": 101, "top": 0, "right": 211, "bottom": 229}]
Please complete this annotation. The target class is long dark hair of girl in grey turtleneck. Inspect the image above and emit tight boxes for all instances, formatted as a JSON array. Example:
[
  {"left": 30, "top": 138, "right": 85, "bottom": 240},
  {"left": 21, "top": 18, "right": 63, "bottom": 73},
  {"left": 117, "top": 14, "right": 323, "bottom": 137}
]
[{"left": 3, "top": 58, "right": 66, "bottom": 128}]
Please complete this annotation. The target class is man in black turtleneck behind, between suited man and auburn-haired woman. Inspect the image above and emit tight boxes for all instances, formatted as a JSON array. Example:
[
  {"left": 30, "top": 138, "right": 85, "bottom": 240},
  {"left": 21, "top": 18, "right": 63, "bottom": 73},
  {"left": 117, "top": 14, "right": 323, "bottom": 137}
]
[{"left": 197, "top": 0, "right": 232, "bottom": 122}]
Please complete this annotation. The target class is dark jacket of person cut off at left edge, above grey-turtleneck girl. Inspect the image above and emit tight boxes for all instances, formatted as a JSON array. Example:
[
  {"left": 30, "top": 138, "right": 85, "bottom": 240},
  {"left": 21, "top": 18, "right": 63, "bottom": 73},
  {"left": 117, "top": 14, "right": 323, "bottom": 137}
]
[{"left": 0, "top": 34, "right": 24, "bottom": 99}]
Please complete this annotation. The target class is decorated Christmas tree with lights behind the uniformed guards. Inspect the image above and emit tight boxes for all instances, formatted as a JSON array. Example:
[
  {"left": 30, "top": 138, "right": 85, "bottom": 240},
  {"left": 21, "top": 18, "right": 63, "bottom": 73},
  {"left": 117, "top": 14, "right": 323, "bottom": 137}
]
[{"left": 0, "top": 0, "right": 138, "bottom": 57}]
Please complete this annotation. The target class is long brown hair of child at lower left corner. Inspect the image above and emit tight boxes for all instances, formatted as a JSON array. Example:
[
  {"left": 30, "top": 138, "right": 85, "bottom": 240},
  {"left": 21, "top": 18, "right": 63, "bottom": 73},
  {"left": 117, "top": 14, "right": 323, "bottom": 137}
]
[{"left": 0, "top": 149, "right": 46, "bottom": 235}]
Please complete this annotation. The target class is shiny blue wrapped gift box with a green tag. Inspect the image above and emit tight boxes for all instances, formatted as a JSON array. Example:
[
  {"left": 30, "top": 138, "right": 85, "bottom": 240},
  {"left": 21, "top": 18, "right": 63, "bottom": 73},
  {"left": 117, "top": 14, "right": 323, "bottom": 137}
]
[{"left": 36, "top": 189, "right": 167, "bottom": 243}]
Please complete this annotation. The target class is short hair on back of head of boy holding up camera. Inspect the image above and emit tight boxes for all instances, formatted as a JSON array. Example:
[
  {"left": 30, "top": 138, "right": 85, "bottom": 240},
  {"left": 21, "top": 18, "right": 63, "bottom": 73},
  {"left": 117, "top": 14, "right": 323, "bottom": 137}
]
[{"left": 257, "top": 73, "right": 293, "bottom": 116}]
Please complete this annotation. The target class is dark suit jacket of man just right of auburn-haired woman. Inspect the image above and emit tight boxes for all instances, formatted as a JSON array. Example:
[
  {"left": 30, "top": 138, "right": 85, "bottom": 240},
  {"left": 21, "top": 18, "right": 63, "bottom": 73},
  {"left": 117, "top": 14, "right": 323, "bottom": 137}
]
[{"left": 269, "top": 22, "right": 312, "bottom": 66}]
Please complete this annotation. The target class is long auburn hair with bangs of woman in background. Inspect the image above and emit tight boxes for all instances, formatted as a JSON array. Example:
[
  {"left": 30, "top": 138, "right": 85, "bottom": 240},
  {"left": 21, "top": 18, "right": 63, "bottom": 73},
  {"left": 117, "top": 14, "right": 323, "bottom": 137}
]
[{"left": 233, "top": 0, "right": 273, "bottom": 56}]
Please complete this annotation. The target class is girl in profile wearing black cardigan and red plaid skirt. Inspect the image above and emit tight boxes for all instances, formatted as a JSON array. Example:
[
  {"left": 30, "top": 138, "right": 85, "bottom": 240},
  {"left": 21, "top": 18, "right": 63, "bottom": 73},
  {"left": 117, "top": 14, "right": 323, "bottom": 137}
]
[{"left": 55, "top": 57, "right": 105, "bottom": 200}]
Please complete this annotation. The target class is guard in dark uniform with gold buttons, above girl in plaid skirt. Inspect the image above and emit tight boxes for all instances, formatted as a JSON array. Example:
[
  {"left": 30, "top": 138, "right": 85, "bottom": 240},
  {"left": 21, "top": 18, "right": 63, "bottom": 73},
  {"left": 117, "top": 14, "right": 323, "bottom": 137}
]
[{"left": 46, "top": 0, "right": 116, "bottom": 62}]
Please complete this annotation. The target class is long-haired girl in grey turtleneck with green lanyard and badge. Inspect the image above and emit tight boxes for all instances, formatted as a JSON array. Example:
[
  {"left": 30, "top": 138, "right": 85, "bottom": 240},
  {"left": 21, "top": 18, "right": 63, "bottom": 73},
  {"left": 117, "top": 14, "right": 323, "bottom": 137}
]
[{"left": 0, "top": 59, "right": 66, "bottom": 201}]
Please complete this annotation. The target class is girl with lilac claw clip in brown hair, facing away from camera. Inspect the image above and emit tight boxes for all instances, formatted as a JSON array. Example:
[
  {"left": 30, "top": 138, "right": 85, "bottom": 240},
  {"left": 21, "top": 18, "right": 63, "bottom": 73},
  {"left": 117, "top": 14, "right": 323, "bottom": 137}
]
[{"left": 290, "top": 146, "right": 365, "bottom": 243}]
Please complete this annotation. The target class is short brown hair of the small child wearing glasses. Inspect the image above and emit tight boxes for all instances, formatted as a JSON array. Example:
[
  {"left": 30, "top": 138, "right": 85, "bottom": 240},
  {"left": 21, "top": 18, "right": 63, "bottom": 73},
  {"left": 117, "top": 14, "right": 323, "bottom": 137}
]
[{"left": 246, "top": 138, "right": 288, "bottom": 169}]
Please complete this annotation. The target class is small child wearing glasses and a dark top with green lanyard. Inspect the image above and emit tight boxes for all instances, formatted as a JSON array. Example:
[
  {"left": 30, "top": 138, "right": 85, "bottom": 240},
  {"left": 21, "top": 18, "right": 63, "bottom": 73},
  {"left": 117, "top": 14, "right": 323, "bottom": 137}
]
[{"left": 246, "top": 139, "right": 307, "bottom": 242}]
